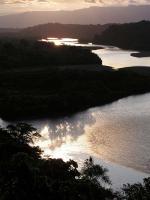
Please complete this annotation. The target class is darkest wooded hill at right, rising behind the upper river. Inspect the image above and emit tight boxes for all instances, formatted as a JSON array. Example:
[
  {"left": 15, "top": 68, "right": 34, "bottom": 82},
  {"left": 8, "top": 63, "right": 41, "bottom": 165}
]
[{"left": 94, "top": 21, "right": 150, "bottom": 51}]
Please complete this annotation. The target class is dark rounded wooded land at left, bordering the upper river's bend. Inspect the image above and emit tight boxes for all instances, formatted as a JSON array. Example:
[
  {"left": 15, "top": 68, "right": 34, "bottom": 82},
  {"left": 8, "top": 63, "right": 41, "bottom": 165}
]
[{"left": 0, "top": 38, "right": 101, "bottom": 69}]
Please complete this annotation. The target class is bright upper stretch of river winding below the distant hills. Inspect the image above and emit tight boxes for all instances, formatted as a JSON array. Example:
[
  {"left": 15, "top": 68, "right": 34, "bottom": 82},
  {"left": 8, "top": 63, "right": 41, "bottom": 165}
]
[{"left": 41, "top": 38, "right": 150, "bottom": 69}]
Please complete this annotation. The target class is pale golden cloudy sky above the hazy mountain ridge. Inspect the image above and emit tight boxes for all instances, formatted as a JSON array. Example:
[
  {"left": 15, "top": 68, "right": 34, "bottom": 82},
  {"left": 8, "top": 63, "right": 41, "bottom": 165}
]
[{"left": 0, "top": 0, "right": 150, "bottom": 15}]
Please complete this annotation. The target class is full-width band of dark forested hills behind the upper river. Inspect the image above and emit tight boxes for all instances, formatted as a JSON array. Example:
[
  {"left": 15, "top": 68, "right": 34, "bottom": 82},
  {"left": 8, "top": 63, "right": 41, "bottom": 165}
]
[{"left": 0, "top": 21, "right": 150, "bottom": 51}]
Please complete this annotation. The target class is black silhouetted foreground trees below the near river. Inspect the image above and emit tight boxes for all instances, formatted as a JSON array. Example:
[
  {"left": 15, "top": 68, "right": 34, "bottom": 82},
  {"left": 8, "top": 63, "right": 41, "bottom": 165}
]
[{"left": 0, "top": 123, "right": 150, "bottom": 200}]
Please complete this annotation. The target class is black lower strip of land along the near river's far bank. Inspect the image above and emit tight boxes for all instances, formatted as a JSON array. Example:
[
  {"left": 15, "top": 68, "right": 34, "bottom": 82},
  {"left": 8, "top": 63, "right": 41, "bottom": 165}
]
[{"left": 0, "top": 65, "right": 150, "bottom": 120}]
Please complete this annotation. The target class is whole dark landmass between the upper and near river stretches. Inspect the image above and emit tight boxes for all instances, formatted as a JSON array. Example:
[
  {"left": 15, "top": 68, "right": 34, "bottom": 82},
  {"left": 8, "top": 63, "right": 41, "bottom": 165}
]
[{"left": 0, "top": 39, "right": 150, "bottom": 119}]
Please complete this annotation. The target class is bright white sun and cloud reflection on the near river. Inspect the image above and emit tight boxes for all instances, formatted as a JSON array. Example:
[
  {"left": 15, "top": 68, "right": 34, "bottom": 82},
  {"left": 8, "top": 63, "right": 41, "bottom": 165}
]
[{"left": 35, "top": 125, "right": 90, "bottom": 161}]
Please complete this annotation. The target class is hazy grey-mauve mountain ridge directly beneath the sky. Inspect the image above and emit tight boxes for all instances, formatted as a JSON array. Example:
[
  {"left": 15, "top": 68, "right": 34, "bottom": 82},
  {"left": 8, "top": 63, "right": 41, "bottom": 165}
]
[{"left": 0, "top": 5, "right": 150, "bottom": 28}]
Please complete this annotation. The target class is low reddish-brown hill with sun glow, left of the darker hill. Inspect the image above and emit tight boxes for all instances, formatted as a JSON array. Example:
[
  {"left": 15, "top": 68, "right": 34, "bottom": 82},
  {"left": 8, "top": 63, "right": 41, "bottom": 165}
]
[{"left": 0, "top": 23, "right": 109, "bottom": 41}]
